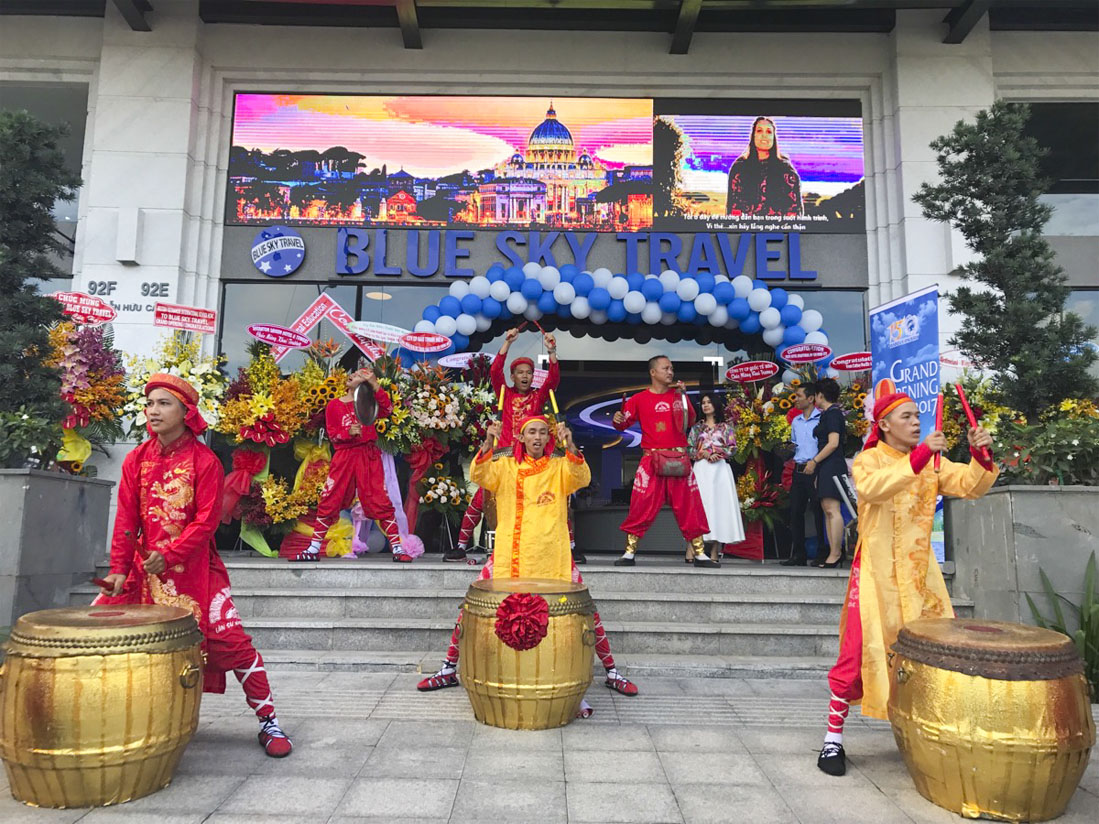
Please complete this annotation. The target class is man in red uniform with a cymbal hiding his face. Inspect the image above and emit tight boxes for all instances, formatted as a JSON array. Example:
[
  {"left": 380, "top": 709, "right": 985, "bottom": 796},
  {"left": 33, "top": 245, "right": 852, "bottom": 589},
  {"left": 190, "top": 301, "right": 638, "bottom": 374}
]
[{"left": 293, "top": 366, "right": 412, "bottom": 564}]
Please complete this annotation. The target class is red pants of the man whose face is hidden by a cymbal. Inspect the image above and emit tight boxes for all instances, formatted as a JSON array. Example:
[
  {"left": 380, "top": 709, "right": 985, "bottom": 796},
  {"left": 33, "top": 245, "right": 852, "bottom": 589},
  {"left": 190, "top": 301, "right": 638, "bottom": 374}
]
[{"left": 313, "top": 444, "right": 401, "bottom": 552}]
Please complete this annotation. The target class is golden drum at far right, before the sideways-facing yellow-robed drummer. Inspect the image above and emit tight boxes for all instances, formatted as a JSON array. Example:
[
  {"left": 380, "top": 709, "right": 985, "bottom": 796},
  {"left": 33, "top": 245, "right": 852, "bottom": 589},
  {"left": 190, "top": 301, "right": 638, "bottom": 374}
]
[{"left": 889, "top": 619, "right": 1096, "bottom": 821}]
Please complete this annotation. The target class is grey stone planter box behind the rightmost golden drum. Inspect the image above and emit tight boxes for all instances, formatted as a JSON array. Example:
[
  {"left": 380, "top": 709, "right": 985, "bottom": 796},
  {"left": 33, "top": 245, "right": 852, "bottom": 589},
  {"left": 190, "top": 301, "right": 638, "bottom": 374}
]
[{"left": 945, "top": 486, "right": 1099, "bottom": 624}]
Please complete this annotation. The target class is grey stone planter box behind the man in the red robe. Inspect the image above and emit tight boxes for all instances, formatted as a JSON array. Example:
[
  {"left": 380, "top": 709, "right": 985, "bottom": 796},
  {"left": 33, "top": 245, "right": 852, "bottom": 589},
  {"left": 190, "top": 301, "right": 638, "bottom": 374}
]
[{"left": 0, "top": 469, "right": 114, "bottom": 626}]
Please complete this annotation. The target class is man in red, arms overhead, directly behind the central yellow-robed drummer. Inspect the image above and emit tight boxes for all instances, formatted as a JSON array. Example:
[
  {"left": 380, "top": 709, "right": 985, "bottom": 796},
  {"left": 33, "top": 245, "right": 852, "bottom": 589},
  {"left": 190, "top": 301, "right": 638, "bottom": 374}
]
[{"left": 443, "top": 327, "right": 571, "bottom": 560}]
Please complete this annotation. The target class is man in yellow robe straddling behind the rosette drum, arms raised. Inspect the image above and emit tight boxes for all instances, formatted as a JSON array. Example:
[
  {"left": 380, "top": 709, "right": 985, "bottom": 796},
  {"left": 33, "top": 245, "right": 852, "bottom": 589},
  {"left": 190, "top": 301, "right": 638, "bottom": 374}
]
[{"left": 417, "top": 415, "right": 637, "bottom": 695}]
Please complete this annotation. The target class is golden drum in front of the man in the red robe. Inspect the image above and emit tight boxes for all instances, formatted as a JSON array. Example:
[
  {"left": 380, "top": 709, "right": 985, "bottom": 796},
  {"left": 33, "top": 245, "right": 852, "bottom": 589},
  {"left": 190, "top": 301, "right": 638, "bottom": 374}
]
[{"left": 0, "top": 605, "right": 202, "bottom": 808}]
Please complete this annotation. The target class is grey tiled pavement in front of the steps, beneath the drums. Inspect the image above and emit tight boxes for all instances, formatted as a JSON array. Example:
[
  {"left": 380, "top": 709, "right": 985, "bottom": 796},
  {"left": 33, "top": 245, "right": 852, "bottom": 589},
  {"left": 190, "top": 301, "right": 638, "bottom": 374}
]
[{"left": 0, "top": 672, "right": 1099, "bottom": 824}]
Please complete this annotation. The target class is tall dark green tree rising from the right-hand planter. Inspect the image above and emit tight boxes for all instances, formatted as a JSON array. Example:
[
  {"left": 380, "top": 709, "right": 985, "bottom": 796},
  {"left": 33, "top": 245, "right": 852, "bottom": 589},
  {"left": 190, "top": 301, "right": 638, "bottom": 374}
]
[{"left": 913, "top": 100, "right": 1099, "bottom": 420}]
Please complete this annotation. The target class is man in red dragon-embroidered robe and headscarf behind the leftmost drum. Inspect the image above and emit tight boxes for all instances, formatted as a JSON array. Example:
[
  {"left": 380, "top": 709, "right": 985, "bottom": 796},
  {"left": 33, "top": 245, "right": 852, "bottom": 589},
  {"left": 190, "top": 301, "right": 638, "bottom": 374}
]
[{"left": 95, "top": 375, "right": 292, "bottom": 758}]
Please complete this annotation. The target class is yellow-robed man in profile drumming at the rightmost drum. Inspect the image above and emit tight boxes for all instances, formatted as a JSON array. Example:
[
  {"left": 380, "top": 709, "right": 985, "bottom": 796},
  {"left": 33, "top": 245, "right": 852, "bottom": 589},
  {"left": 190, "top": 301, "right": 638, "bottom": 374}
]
[{"left": 817, "top": 381, "right": 999, "bottom": 776}]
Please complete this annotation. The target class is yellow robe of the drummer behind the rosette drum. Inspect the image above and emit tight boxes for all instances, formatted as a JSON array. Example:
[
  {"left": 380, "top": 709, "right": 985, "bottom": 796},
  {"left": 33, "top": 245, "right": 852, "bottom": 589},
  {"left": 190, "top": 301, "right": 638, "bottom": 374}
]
[{"left": 469, "top": 452, "right": 591, "bottom": 581}]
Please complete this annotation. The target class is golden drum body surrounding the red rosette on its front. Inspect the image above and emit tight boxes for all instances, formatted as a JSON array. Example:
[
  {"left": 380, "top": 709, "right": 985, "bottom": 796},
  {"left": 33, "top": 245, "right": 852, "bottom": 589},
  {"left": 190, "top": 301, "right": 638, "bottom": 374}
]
[{"left": 458, "top": 578, "right": 596, "bottom": 730}]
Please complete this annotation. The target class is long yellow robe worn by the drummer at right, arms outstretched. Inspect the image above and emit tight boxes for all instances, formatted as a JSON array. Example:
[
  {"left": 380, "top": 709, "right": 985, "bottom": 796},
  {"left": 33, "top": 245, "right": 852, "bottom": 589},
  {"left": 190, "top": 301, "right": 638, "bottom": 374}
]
[{"left": 841, "top": 442, "right": 999, "bottom": 719}]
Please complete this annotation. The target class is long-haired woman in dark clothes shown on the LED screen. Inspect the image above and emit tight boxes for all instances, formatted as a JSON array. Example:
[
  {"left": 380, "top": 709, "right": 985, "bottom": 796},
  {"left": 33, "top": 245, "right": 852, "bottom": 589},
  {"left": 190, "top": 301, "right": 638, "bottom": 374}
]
[{"left": 725, "top": 118, "right": 801, "bottom": 216}]
